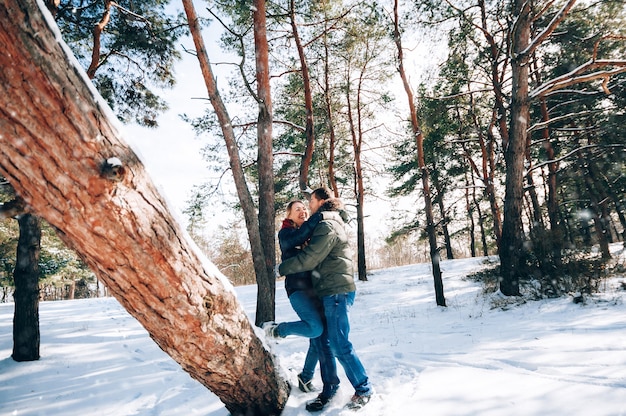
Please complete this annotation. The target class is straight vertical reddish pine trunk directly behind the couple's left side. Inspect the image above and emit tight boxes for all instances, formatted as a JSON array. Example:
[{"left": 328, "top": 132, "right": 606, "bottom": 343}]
[{"left": 252, "top": 0, "right": 276, "bottom": 325}]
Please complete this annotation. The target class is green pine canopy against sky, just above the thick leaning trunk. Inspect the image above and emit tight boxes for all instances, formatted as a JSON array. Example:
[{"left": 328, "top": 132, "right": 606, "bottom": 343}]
[{"left": 53, "top": 0, "right": 187, "bottom": 127}]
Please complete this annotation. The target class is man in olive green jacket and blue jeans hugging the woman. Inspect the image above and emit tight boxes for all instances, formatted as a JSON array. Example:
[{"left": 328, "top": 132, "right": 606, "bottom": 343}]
[{"left": 278, "top": 188, "right": 373, "bottom": 411}]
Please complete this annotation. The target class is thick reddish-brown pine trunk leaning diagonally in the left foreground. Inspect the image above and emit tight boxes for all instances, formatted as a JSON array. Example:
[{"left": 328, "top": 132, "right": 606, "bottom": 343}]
[{"left": 0, "top": 0, "right": 289, "bottom": 415}]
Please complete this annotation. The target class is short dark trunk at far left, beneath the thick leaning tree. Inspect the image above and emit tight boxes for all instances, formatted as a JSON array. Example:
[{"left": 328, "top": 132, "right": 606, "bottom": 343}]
[{"left": 11, "top": 214, "right": 41, "bottom": 361}]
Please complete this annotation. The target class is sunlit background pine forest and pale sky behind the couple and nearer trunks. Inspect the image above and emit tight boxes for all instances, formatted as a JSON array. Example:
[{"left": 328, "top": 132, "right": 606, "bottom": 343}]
[{"left": 1, "top": 1, "right": 626, "bottom": 300}]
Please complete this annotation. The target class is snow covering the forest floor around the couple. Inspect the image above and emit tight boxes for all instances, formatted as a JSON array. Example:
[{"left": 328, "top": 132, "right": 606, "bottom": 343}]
[{"left": 0, "top": 250, "right": 626, "bottom": 416}]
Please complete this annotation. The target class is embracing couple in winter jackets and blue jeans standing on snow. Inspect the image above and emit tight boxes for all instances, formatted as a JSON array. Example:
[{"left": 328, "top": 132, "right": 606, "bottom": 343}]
[{"left": 264, "top": 188, "right": 373, "bottom": 412}]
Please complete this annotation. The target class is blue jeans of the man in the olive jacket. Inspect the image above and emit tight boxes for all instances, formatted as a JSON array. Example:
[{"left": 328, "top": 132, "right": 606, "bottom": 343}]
[{"left": 322, "top": 292, "right": 372, "bottom": 396}]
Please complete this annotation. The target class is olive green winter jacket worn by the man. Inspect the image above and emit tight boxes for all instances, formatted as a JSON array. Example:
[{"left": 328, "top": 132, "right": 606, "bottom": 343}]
[{"left": 278, "top": 199, "right": 356, "bottom": 297}]
